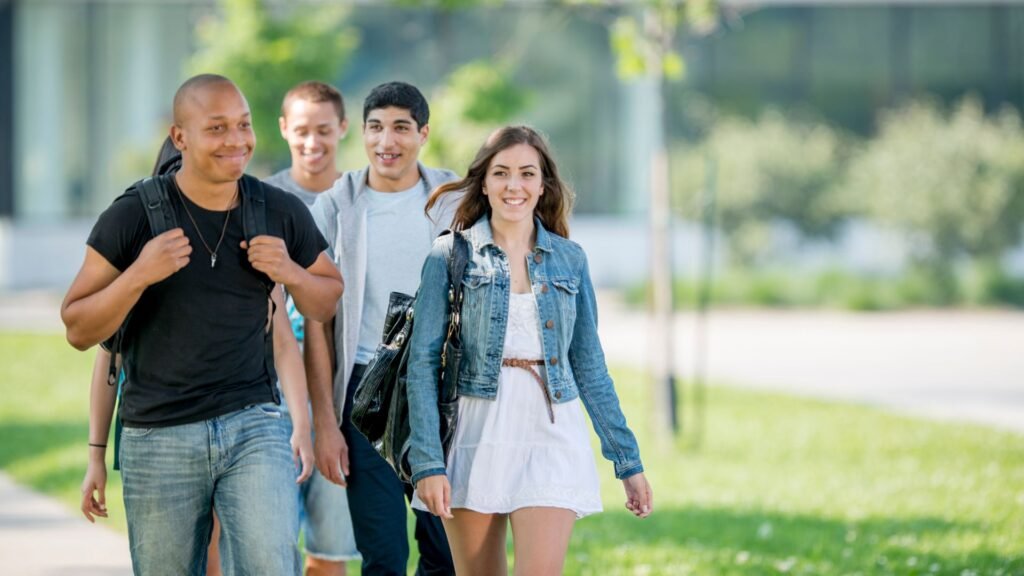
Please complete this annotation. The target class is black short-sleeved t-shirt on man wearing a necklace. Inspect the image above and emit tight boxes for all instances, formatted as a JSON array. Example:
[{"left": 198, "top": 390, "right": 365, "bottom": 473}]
[{"left": 87, "top": 179, "right": 327, "bottom": 427}]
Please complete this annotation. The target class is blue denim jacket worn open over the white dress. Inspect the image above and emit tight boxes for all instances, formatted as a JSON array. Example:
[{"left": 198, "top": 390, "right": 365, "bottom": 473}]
[{"left": 408, "top": 216, "right": 643, "bottom": 484}]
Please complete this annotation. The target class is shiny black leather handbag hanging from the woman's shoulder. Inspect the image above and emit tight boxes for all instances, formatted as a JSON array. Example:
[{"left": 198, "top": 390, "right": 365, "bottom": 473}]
[{"left": 351, "top": 231, "right": 469, "bottom": 484}]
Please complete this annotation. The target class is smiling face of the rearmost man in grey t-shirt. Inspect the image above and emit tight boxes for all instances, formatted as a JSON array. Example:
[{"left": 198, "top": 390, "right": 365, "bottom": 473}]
[{"left": 279, "top": 98, "right": 348, "bottom": 176}]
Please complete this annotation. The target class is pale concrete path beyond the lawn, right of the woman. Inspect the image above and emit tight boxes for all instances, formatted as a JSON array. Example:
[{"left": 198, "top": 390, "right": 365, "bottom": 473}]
[{"left": 600, "top": 299, "right": 1024, "bottom": 433}]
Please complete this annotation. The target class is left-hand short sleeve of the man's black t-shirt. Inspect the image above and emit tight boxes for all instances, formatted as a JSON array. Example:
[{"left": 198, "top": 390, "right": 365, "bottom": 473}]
[{"left": 85, "top": 191, "right": 151, "bottom": 272}]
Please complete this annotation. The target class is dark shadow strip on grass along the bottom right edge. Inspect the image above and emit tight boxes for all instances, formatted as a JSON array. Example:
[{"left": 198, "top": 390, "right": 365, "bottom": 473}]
[{"left": 566, "top": 507, "right": 1024, "bottom": 575}]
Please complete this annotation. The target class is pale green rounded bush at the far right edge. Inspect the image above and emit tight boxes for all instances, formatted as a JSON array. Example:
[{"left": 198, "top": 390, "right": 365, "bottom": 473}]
[{"left": 845, "top": 98, "right": 1024, "bottom": 300}]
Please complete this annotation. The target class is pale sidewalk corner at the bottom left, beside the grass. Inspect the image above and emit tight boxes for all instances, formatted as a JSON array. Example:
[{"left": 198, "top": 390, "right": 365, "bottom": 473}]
[{"left": 0, "top": 471, "right": 132, "bottom": 576}]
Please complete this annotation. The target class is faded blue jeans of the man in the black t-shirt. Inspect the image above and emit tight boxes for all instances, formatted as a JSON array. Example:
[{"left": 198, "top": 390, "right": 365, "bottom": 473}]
[{"left": 121, "top": 404, "right": 299, "bottom": 576}]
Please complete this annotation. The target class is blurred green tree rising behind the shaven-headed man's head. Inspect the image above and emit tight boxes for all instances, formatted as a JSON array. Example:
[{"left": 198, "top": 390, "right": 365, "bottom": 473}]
[{"left": 186, "top": 0, "right": 359, "bottom": 167}]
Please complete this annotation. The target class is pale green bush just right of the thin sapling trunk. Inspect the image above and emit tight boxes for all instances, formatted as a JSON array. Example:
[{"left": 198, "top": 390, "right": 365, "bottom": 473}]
[{"left": 672, "top": 111, "right": 852, "bottom": 264}]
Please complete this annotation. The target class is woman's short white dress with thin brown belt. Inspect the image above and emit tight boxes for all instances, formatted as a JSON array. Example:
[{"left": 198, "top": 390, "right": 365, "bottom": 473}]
[{"left": 413, "top": 293, "right": 601, "bottom": 518}]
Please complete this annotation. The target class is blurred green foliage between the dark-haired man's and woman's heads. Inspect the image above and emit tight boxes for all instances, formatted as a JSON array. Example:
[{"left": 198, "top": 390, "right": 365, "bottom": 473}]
[{"left": 422, "top": 59, "right": 530, "bottom": 174}]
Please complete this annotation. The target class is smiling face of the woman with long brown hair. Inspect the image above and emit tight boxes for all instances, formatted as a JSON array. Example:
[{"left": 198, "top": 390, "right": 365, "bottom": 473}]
[{"left": 483, "top": 143, "right": 544, "bottom": 224}]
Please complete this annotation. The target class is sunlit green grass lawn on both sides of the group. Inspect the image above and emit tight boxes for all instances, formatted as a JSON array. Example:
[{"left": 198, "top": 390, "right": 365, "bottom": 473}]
[{"left": 0, "top": 334, "right": 1024, "bottom": 576}]
